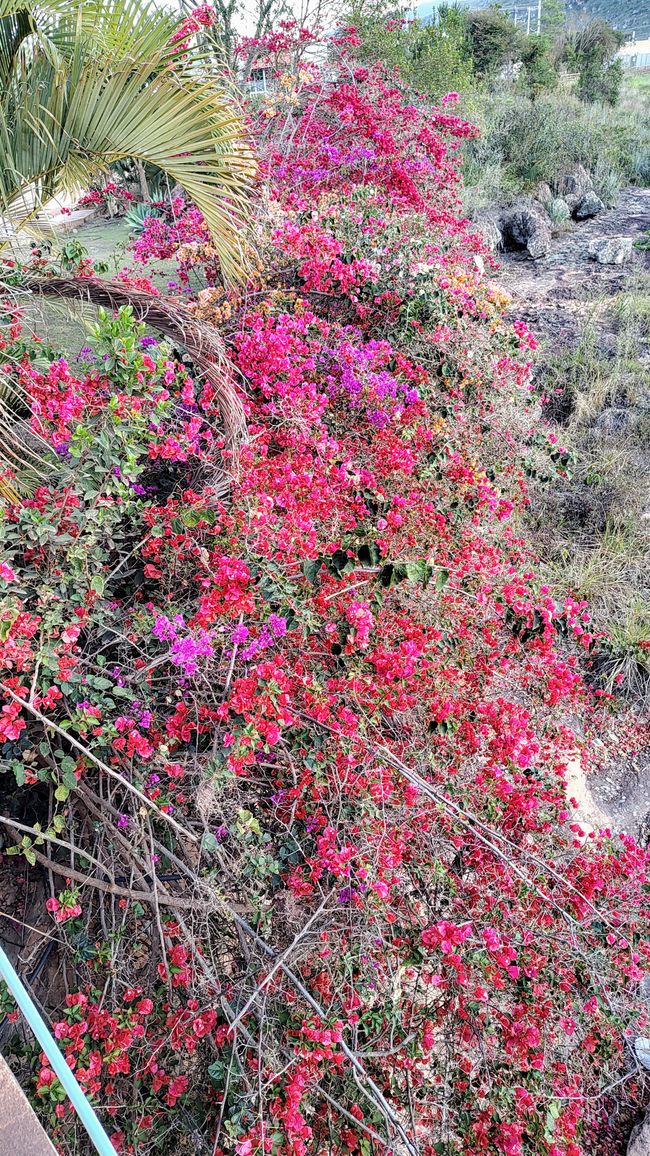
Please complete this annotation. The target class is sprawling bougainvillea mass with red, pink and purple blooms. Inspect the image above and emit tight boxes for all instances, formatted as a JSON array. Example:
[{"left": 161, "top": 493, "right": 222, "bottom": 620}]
[{"left": 0, "top": 24, "right": 649, "bottom": 1156}]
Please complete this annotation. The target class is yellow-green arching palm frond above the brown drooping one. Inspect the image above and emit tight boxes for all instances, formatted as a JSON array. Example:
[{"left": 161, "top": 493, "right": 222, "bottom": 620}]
[{"left": 0, "top": 0, "right": 253, "bottom": 279}]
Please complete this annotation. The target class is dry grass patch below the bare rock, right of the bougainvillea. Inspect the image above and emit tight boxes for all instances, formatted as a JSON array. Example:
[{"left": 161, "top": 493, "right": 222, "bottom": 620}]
[{"left": 522, "top": 274, "right": 650, "bottom": 706}]
